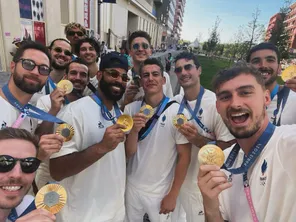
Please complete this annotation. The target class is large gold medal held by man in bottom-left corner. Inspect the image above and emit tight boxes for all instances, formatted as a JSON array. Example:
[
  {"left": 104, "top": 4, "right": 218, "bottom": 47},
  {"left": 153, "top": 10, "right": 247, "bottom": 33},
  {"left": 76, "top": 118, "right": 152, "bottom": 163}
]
[{"left": 35, "top": 184, "right": 67, "bottom": 214}]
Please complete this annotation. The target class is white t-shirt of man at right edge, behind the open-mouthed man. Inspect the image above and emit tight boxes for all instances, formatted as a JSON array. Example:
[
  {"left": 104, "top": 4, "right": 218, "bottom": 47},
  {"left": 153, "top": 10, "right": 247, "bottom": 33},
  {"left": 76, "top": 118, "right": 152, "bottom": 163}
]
[{"left": 267, "top": 90, "right": 296, "bottom": 125}]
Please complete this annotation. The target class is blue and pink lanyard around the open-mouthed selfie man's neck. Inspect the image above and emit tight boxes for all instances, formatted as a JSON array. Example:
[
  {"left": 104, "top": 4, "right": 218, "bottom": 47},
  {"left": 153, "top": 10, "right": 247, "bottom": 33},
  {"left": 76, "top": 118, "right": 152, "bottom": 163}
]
[{"left": 222, "top": 123, "right": 275, "bottom": 222}]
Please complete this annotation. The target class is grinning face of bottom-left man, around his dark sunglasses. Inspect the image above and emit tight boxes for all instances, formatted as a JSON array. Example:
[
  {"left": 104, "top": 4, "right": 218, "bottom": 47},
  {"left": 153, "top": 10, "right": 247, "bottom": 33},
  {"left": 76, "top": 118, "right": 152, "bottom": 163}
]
[{"left": 0, "top": 139, "right": 36, "bottom": 209}]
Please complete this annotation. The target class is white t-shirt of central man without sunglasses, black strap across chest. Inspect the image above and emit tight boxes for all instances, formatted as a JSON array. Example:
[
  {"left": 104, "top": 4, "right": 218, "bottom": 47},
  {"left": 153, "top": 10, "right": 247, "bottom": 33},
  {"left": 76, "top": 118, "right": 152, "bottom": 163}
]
[{"left": 124, "top": 101, "right": 188, "bottom": 195}]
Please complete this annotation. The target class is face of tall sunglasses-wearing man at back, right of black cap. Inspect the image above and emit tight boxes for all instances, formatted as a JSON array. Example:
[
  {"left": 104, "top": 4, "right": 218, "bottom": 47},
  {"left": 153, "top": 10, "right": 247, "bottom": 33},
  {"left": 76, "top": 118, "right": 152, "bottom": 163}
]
[{"left": 130, "top": 37, "right": 151, "bottom": 63}]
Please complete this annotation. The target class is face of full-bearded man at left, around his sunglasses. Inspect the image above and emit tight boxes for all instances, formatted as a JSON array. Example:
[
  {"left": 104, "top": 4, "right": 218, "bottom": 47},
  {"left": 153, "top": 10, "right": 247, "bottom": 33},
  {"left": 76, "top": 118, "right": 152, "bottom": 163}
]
[{"left": 11, "top": 49, "right": 50, "bottom": 94}]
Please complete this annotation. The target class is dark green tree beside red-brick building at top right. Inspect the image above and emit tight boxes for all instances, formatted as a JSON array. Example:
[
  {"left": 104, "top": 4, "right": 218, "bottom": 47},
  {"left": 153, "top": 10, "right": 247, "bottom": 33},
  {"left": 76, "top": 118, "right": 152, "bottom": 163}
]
[{"left": 269, "top": 0, "right": 291, "bottom": 59}]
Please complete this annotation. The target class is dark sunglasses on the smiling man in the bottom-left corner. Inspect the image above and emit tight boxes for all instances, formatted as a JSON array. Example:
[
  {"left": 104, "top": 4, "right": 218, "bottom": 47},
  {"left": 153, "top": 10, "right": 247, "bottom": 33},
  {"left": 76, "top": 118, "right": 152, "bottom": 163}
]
[{"left": 0, "top": 155, "right": 41, "bottom": 173}]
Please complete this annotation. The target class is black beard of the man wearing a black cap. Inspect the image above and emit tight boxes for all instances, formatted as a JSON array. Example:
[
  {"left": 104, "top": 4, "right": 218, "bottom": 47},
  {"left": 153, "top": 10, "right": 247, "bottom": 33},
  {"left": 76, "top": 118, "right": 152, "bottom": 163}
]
[{"left": 99, "top": 76, "right": 125, "bottom": 102}]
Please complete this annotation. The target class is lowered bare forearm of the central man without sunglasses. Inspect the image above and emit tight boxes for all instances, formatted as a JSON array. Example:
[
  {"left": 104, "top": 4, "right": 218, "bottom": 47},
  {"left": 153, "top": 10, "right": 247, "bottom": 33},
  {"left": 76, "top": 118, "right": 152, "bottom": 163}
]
[{"left": 170, "top": 148, "right": 191, "bottom": 196}]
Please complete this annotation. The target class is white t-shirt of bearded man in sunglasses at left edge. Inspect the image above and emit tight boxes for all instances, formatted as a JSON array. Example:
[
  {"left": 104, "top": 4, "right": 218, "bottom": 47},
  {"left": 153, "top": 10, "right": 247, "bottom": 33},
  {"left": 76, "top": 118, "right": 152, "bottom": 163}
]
[{"left": 0, "top": 96, "right": 37, "bottom": 133}]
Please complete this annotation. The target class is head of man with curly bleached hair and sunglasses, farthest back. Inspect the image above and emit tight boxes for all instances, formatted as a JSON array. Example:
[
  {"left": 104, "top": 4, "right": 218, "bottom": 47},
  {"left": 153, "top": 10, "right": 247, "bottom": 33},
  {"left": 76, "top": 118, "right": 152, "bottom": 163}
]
[{"left": 65, "top": 22, "right": 86, "bottom": 54}]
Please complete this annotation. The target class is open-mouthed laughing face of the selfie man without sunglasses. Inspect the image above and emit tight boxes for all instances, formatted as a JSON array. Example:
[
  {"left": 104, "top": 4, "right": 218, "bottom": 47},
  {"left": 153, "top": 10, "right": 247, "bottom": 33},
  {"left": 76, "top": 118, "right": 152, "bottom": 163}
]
[{"left": 216, "top": 74, "right": 270, "bottom": 139}]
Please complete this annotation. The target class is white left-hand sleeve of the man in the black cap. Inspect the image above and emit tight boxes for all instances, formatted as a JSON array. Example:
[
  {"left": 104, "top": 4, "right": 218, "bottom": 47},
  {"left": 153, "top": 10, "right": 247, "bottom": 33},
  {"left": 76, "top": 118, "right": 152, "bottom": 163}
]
[{"left": 50, "top": 107, "right": 84, "bottom": 159}]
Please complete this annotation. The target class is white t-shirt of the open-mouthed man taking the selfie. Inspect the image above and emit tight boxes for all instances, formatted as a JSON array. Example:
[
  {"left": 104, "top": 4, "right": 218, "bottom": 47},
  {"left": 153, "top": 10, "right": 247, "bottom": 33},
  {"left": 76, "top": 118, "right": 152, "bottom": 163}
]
[{"left": 219, "top": 125, "right": 296, "bottom": 222}]
